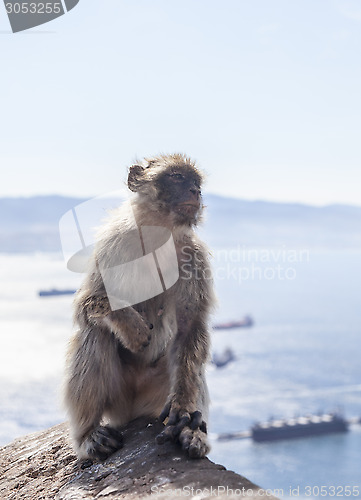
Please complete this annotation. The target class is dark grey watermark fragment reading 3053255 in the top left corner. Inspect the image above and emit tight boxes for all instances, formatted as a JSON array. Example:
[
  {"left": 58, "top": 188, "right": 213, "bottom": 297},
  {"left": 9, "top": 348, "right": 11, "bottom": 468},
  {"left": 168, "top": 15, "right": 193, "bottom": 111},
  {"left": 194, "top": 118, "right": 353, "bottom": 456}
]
[{"left": 4, "top": 0, "right": 79, "bottom": 33}]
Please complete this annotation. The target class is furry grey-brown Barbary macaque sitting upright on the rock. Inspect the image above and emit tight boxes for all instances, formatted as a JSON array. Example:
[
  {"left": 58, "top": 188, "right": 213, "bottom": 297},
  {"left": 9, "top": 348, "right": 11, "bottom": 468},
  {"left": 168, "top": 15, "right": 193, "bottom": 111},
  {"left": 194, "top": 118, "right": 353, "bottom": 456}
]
[{"left": 65, "top": 154, "right": 214, "bottom": 460}]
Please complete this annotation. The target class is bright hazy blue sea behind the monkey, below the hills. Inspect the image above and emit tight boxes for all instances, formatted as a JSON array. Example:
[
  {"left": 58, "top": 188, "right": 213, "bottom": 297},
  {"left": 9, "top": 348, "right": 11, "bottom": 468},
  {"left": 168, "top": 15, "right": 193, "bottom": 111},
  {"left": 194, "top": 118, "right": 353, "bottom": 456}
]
[{"left": 0, "top": 246, "right": 361, "bottom": 499}]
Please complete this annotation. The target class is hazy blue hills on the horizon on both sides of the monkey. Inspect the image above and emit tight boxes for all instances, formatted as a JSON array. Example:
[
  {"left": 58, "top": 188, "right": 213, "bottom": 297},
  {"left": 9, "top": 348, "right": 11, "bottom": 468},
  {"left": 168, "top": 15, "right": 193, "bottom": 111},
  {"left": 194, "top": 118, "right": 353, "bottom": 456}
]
[{"left": 0, "top": 194, "right": 361, "bottom": 252}]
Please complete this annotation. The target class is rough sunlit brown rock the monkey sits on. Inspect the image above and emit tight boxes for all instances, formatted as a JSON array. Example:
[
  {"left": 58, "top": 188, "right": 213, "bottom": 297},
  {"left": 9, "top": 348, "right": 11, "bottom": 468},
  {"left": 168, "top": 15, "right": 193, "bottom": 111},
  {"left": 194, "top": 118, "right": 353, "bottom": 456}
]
[{"left": 0, "top": 419, "right": 275, "bottom": 500}]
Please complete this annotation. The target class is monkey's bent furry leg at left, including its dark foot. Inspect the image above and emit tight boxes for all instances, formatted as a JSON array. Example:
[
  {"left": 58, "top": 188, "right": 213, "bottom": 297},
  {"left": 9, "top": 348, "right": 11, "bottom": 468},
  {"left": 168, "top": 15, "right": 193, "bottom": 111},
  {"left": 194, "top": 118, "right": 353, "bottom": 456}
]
[{"left": 65, "top": 326, "right": 127, "bottom": 460}]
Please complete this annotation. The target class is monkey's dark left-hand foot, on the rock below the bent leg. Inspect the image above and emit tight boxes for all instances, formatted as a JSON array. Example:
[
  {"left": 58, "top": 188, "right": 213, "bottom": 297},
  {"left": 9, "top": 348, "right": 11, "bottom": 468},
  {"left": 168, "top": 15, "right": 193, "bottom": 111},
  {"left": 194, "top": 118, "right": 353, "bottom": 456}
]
[{"left": 81, "top": 426, "right": 123, "bottom": 461}]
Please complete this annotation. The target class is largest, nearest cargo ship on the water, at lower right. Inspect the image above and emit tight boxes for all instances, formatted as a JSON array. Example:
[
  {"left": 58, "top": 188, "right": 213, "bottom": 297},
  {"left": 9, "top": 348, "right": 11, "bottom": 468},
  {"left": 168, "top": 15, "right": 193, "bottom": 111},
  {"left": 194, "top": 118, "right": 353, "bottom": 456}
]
[{"left": 251, "top": 413, "right": 348, "bottom": 443}]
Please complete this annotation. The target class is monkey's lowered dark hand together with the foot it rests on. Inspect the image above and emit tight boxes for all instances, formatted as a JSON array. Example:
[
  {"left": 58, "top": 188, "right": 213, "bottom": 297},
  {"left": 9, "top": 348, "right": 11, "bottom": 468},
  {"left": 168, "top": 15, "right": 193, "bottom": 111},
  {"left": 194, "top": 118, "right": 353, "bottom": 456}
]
[{"left": 156, "top": 403, "right": 210, "bottom": 458}]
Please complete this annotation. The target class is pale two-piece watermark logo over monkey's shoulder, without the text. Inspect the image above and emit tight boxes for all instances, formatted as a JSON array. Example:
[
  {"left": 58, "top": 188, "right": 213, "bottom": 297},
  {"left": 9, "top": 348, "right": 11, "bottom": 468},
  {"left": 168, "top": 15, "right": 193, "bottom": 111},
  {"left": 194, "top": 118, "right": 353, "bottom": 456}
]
[{"left": 59, "top": 193, "right": 179, "bottom": 311}]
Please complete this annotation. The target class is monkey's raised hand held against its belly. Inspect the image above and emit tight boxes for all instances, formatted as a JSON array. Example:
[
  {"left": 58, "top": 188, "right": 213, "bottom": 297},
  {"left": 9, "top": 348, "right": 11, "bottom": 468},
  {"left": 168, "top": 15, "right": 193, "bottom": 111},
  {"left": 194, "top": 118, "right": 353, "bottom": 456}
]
[{"left": 104, "top": 307, "right": 153, "bottom": 353}]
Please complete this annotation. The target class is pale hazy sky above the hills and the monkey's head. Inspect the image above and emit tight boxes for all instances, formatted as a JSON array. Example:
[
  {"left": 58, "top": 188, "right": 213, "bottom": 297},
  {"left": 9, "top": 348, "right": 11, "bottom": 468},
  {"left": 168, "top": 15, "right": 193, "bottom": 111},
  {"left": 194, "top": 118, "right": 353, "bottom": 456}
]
[{"left": 0, "top": 0, "right": 361, "bottom": 205}]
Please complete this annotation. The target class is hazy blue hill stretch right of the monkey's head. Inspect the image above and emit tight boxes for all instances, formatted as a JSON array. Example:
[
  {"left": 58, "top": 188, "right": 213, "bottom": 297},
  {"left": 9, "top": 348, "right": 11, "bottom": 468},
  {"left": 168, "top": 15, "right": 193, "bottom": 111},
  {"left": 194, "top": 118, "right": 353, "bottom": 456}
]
[{"left": 201, "top": 195, "right": 361, "bottom": 249}]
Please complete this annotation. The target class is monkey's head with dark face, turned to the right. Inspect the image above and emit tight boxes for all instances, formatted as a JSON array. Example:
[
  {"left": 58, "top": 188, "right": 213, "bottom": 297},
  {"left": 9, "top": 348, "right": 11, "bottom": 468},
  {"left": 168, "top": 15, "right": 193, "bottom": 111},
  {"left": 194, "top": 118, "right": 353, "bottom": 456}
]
[{"left": 128, "top": 154, "right": 203, "bottom": 225}]
